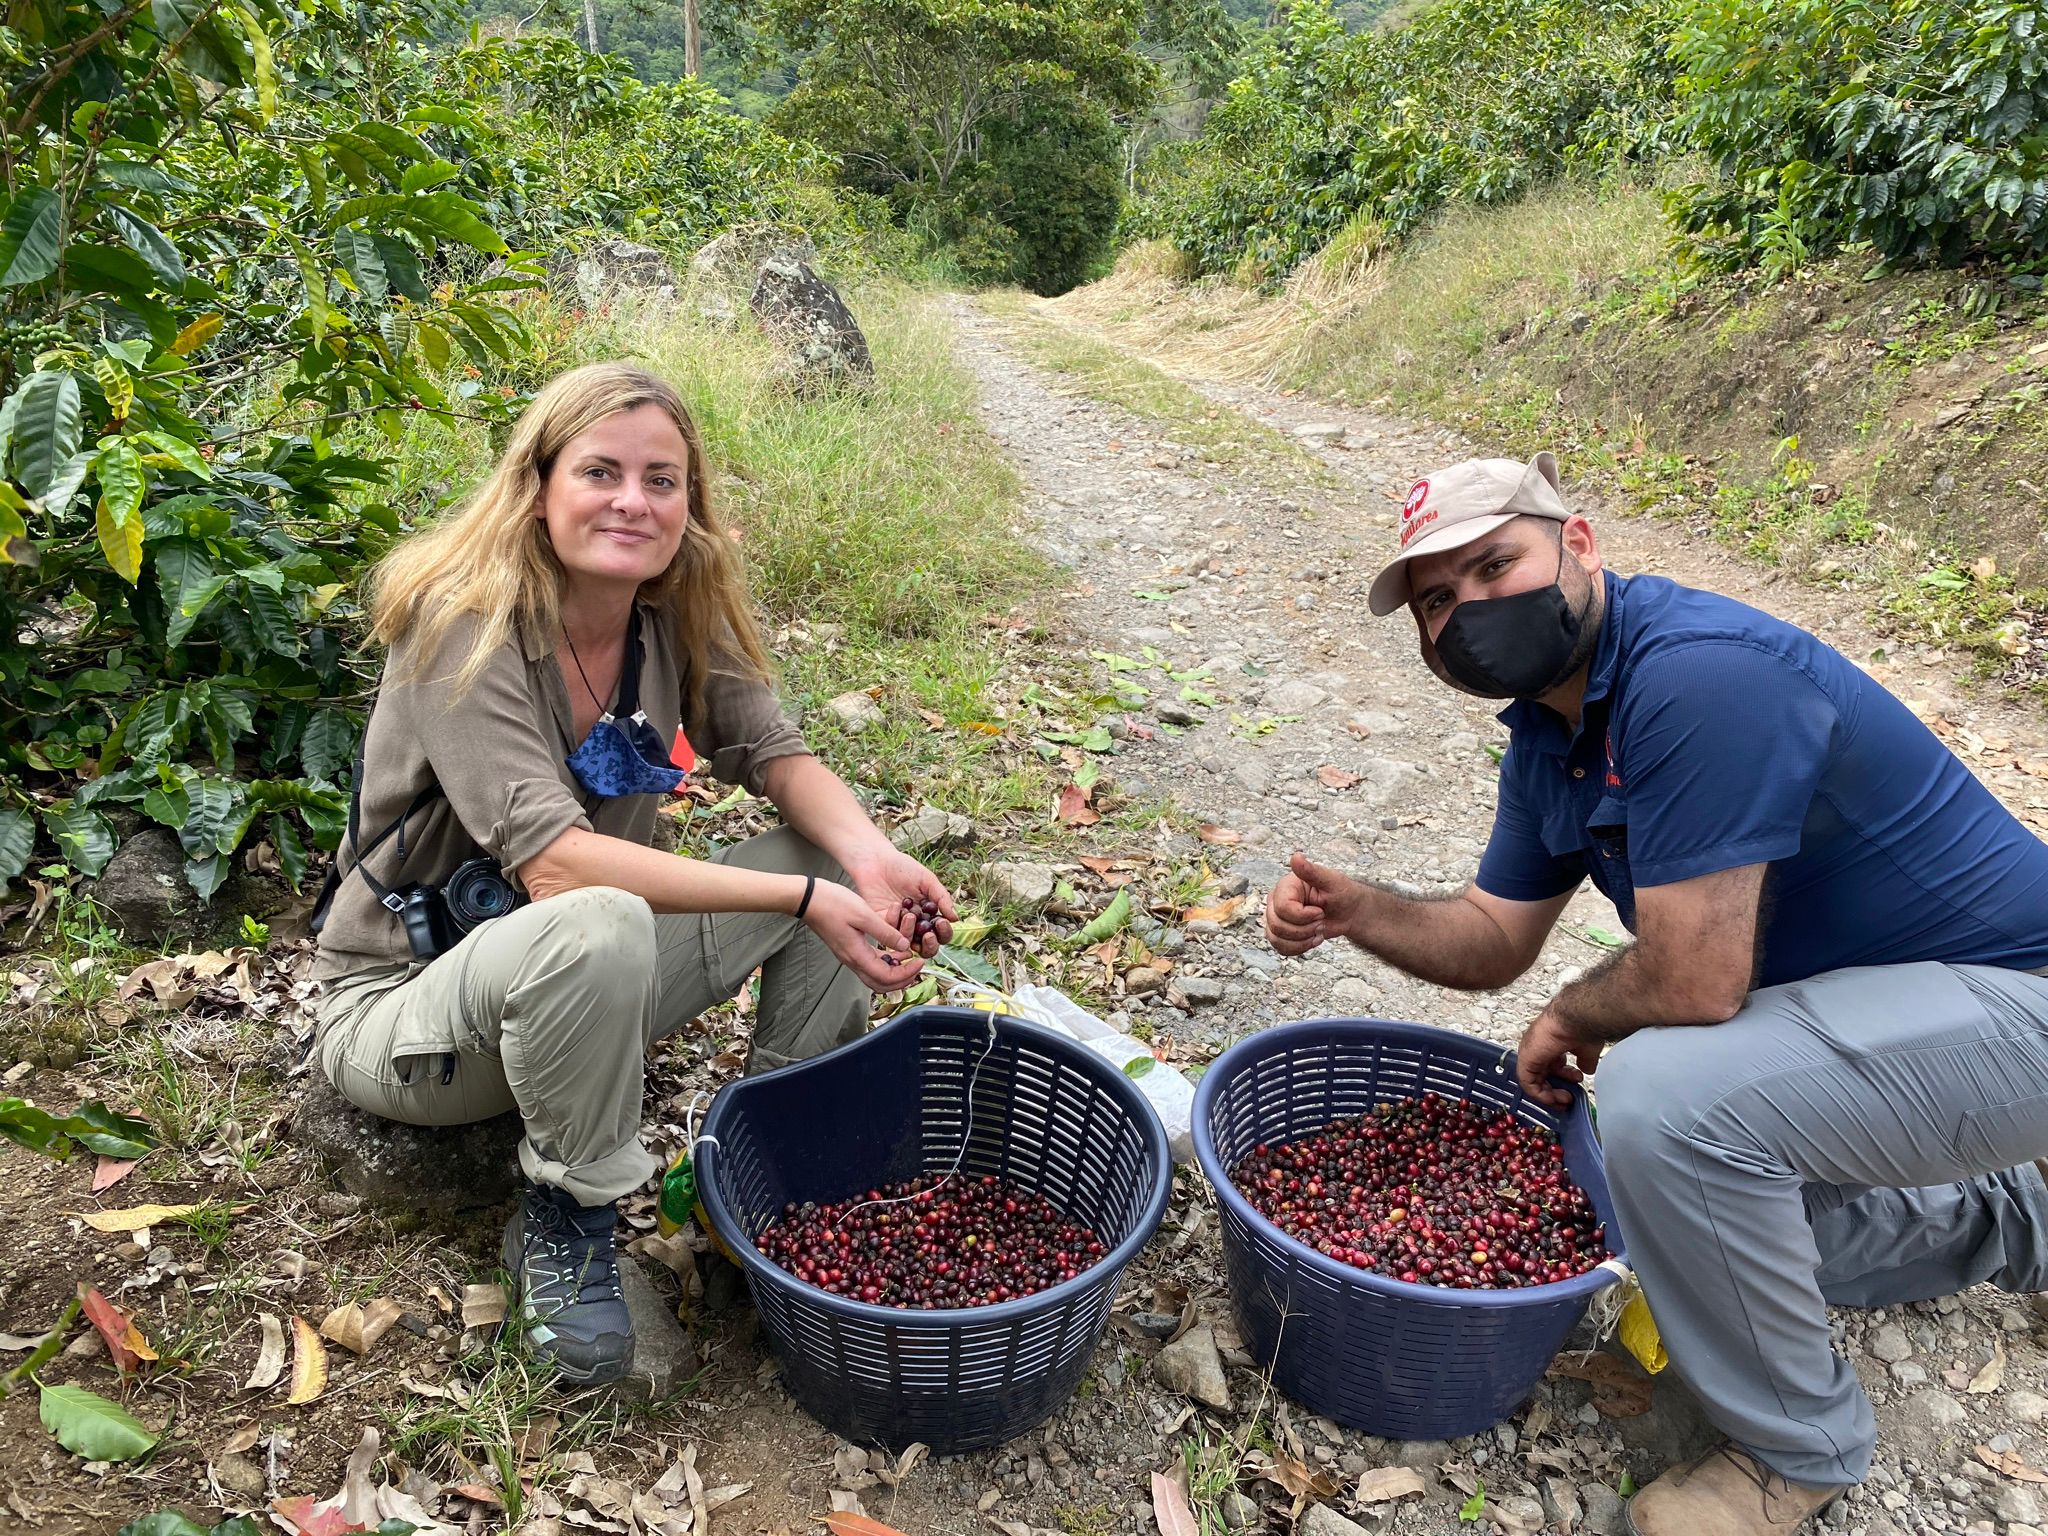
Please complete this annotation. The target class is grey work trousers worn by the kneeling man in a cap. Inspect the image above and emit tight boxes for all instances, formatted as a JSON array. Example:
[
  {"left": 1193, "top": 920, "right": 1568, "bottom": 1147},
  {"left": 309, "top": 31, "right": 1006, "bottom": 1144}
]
[{"left": 1597, "top": 965, "right": 2048, "bottom": 1487}]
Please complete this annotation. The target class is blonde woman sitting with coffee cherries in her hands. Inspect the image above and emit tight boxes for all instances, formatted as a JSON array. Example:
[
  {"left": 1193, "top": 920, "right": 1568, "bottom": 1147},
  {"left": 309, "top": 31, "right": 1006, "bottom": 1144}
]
[{"left": 315, "top": 362, "right": 954, "bottom": 1382}]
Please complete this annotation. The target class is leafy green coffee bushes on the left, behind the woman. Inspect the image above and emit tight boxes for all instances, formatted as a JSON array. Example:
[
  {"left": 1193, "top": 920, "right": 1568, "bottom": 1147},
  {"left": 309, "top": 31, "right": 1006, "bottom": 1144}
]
[{"left": 0, "top": 0, "right": 836, "bottom": 897}]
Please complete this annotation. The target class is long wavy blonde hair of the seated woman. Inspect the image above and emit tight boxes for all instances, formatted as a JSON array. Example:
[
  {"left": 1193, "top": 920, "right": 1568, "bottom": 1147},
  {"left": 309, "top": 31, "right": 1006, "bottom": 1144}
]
[{"left": 371, "top": 362, "right": 770, "bottom": 719}]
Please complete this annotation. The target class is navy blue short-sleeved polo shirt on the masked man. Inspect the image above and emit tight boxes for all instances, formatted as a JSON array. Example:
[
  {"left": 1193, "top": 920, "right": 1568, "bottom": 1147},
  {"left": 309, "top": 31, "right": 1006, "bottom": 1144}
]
[{"left": 1479, "top": 571, "right": 2048, "bottom": 985}]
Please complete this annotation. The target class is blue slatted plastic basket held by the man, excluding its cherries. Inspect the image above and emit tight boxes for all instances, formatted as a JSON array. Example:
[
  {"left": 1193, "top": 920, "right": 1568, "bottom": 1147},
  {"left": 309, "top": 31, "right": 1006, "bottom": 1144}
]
[{"left": 1194, "top": 1018, "right": 1622, "bottom": 1440}]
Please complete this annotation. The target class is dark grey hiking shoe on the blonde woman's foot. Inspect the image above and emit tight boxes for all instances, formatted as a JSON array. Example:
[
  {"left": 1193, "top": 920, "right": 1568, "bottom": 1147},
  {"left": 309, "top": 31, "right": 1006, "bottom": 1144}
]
[{"left": 504, "top": 1182, "right": 633, "bottom": 1384}]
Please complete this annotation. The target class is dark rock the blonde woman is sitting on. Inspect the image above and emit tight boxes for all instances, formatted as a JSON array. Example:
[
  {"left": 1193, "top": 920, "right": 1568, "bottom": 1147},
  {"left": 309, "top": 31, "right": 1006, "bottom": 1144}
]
[{"left": 291, "top": 1067, "right": 520, "bottom": 1214}]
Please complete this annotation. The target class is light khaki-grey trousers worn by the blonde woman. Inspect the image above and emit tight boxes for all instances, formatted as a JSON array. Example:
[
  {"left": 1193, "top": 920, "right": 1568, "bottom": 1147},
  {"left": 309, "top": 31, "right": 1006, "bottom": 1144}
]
[{"left": 319, "top": 827, "right": 870, "bottom": 1206}]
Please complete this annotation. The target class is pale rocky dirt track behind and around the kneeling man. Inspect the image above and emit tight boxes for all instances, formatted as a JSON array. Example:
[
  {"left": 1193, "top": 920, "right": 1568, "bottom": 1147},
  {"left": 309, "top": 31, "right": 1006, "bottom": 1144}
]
[{"left": 937, "top": 303, "right": 2048, "bottom": 1536}]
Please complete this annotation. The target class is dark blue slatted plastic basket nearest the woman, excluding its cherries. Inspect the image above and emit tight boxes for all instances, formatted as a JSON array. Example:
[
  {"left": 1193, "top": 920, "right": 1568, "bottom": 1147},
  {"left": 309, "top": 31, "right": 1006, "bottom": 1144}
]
[{"left": 696, "top": 1008, "right": 1174, "bottom": 1454}]
